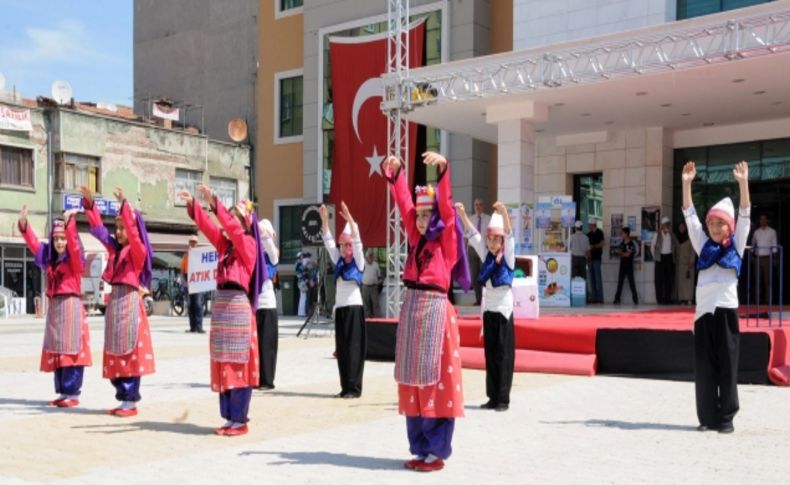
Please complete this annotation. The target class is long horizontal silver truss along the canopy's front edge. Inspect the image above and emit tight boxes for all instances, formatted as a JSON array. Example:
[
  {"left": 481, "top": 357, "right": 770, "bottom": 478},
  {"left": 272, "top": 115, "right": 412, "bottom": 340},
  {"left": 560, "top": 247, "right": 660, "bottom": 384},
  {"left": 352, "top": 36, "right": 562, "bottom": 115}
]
[{"left": 392, "top": 7, "right": 790, "bottom": 112}]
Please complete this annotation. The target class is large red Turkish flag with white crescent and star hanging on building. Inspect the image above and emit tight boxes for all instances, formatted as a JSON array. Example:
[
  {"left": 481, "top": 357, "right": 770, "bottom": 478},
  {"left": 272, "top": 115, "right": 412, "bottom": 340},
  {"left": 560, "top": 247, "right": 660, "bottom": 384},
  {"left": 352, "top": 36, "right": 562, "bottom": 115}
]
[{"left": 329, "top": 22, "right": 425, "bottom": 247}]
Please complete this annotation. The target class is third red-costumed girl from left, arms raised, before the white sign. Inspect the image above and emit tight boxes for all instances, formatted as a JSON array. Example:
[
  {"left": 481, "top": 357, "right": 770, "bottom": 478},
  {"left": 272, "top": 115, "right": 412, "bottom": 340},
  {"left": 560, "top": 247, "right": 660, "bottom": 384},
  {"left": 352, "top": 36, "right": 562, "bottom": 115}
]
[{"left": 179, "top": 185, "right": 267, "bottom": 436}]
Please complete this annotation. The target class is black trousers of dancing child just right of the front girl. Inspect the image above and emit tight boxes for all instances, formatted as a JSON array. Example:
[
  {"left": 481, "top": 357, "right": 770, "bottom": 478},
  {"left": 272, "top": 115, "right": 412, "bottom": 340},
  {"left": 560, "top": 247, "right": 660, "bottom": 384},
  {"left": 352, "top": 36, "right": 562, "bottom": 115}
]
[{"left": 483, "top": 312, "right": 516, "bottom": 404}]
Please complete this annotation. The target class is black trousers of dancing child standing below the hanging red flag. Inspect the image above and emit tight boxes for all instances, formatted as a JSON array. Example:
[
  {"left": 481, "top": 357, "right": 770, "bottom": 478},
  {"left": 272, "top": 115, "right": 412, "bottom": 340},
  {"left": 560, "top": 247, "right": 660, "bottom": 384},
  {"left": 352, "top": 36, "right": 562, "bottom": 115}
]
[{"left": 335, "top": 305, "right": 367, "bottom": 396}]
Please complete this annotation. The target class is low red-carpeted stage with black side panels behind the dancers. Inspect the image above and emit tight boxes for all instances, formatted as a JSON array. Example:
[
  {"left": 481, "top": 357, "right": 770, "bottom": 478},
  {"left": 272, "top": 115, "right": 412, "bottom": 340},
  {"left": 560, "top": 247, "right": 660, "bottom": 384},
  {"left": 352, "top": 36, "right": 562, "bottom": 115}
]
[{"left": 367, "top": 306, "right": 790, "bottom": 386}]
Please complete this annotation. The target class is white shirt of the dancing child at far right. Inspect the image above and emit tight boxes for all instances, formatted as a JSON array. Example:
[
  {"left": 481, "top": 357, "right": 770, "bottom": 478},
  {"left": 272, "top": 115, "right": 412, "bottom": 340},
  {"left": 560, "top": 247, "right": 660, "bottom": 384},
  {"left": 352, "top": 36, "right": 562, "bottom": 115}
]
[{"left": 683, "top": 206, "right": 751, "bottom": 320}]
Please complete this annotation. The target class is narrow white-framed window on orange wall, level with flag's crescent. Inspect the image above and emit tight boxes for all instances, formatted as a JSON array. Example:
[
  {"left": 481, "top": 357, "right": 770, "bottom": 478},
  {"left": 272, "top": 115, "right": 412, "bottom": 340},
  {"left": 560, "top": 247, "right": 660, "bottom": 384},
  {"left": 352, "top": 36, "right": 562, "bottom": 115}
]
[{"left": 275, "top": 69, "right": 304, "bottom": 143}]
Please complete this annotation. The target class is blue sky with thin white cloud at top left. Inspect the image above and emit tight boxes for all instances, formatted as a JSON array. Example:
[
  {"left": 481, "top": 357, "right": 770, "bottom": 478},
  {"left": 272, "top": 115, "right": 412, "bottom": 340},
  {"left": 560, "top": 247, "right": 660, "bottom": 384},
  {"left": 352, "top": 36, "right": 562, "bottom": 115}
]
[{"left": 0, "top": 0, "right": 133, "bottom": 106}]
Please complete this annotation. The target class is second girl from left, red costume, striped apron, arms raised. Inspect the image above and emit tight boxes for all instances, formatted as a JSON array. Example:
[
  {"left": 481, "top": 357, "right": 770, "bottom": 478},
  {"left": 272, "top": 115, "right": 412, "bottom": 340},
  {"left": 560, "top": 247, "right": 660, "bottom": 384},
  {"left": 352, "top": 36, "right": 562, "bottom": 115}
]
[{"left": 80, "top": 187, "right": 155, "bottom": 417}]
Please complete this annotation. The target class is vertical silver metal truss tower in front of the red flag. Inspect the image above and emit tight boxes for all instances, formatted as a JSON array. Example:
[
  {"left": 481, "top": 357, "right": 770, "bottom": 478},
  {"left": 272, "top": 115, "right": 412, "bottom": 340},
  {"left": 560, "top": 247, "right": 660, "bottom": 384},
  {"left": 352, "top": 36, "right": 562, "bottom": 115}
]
[{"left": 381, "top": 0, "right": 410, "bottom": 318}]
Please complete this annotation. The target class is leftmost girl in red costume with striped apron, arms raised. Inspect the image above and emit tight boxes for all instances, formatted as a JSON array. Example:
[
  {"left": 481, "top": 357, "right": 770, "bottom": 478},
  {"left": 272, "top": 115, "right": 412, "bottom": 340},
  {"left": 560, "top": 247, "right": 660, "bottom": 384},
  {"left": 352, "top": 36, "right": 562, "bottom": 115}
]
[{"left": 18, "top": 206, "right": 92, "bottom": 408}]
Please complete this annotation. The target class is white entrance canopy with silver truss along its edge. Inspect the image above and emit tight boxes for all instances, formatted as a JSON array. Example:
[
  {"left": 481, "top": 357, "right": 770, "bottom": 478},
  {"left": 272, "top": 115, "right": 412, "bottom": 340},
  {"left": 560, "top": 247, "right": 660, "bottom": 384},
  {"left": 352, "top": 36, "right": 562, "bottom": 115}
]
[{"left": 396, "top": 3, "right": 790, "bottom": 143}]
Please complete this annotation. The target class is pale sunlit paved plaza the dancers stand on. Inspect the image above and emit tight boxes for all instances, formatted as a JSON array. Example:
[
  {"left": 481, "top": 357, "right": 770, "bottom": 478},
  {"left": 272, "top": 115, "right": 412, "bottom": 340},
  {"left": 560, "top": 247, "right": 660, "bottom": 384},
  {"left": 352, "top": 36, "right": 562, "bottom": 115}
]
[{"left": 0, "top": 317, "right": 790, "bottom": 484}]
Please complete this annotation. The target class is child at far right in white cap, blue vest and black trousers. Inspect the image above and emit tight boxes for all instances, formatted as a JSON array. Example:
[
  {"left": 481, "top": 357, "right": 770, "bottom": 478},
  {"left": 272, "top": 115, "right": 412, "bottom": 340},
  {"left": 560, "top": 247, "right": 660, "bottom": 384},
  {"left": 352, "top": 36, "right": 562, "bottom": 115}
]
[{"left": 682, "top": 162, "right": 751, "bottom": 433}]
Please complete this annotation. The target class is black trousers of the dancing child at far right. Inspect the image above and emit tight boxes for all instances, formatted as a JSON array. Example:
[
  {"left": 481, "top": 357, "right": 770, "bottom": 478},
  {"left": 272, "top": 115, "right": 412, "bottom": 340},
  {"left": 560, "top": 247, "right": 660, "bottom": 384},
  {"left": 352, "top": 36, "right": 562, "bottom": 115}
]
[{"left": 694, "top": 308, "right": 741, "bottom": 428}]
